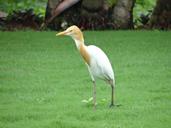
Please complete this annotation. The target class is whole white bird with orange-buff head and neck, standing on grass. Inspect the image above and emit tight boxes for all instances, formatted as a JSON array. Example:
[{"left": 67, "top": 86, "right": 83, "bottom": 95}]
[{"left": 56, "top": 25, "right": 115, "bottom": 109}]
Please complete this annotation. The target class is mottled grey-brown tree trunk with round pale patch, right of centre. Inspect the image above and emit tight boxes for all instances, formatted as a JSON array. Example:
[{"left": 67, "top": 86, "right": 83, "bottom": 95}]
[{"left": 113, "top": 0, "right": 135, "bottom": 29}]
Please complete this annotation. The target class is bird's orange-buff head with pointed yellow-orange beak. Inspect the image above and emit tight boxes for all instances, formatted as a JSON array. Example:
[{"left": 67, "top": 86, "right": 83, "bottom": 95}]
[{"left": 56, "top": 25, "right": 84, "bottom": 42}]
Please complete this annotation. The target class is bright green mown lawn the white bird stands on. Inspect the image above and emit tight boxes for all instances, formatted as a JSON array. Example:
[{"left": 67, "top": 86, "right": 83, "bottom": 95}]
[{"left": 0, "top": 31, "right": 171, "bottom": 128}]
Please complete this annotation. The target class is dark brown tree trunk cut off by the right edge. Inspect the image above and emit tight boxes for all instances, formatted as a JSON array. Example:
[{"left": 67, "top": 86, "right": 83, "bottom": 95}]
[{"left": 149, "top": 0, "right": 171, "bottom": 29}]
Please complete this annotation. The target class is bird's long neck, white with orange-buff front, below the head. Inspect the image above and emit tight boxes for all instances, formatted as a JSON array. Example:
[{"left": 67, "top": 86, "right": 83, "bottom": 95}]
[{"left": 74, "top": 39, "right": 90, "bottom": 65}]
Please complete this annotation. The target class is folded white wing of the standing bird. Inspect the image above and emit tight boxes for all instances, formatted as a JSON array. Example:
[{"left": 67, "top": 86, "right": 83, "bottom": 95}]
[{"left": 87, "top": 45, "right": 114, "bottom": 80}]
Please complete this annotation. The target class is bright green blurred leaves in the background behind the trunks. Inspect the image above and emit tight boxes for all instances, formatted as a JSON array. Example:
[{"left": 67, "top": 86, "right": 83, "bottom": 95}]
[{"left": 0, "top": 0, "right": 156, "bottom": 27}]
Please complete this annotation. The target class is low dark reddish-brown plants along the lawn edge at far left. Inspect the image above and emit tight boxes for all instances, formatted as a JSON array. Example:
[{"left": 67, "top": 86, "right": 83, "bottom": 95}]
[{"left": 0, "top": 9, "right": 43, "bottom": 30}]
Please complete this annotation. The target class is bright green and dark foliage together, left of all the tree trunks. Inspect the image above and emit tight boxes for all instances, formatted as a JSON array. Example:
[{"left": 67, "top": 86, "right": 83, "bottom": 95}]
[{"left": 0, "top": 0, "right": 47, "bottom": 30}]
